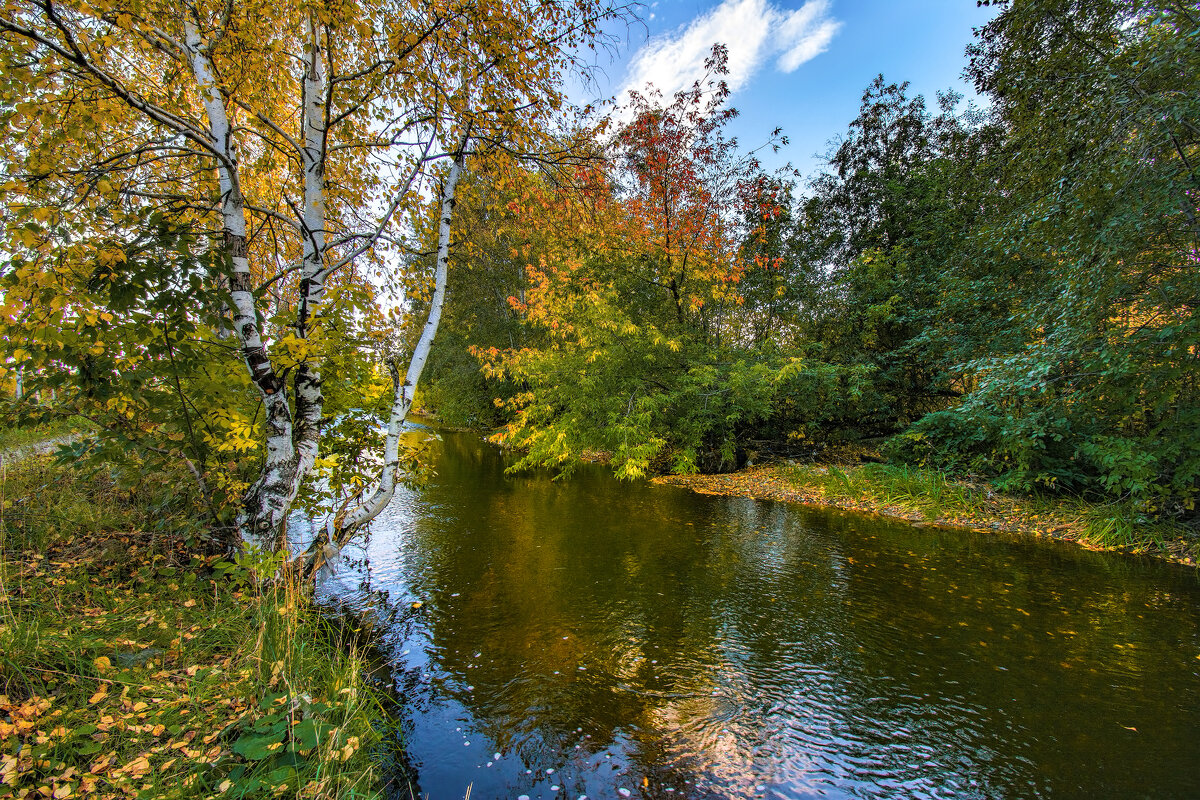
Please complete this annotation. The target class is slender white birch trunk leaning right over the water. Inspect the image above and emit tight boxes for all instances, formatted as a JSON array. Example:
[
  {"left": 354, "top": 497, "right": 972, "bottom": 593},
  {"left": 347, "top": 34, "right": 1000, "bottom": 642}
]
[{"left": 328, "top": 142, "right": 466, "bottom": 544}]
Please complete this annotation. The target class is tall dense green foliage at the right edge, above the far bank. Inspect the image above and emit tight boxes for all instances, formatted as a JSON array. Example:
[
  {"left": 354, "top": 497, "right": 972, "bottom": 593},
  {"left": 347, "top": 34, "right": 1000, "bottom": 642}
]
[{"left": 898, "top": 0, "right": 1200, "bottom": 515}]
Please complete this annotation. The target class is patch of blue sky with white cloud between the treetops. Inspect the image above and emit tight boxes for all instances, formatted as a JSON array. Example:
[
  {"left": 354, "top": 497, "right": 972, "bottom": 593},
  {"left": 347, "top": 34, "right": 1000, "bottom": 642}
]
[{"left": 580, "top": 0, "right": 995, "bottom": 175}]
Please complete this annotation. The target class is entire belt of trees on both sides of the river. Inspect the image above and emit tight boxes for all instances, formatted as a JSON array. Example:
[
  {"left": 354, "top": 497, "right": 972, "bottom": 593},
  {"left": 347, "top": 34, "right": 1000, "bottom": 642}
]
[{"left": 0, "top": 0, "right": 1200, "bottom": 541}]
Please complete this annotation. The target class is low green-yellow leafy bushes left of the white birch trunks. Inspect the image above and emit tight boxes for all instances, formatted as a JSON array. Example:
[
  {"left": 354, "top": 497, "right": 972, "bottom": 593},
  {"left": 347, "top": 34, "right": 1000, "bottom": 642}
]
[{"left": 2, "top": 215, "right": 257, "bottom": 537}]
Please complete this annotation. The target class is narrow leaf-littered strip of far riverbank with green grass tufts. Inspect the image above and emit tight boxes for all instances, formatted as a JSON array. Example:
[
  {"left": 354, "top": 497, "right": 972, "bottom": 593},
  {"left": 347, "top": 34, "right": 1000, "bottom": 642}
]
[{"left": 652, "top": 464, "right": 1200, "bottom": 566}]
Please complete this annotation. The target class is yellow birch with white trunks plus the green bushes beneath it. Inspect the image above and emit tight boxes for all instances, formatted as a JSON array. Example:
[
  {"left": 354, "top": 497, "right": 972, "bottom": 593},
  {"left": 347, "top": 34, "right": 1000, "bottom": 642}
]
[{"left": 0, "top": 1, "right": 617, "bottom": 554}]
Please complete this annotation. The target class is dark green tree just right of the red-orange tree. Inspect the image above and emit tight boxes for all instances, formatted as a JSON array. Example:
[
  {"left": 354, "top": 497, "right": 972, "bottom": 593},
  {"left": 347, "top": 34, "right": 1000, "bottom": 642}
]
[{"left": 793, "top": 76, "right": 1008, "bottom": 434}]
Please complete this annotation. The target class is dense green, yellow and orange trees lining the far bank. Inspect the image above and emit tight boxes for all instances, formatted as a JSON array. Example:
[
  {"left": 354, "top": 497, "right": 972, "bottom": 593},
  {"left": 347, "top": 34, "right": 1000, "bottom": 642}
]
[{"left": 424, "top": 2, "right": 1200, "bottom": 532}]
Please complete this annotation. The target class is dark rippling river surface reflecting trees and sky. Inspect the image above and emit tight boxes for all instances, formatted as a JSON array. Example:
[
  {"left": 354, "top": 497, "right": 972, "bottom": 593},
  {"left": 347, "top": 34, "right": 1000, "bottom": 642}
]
[{"left": 319, "top": 433, "right": 1200, "bottom": 800}]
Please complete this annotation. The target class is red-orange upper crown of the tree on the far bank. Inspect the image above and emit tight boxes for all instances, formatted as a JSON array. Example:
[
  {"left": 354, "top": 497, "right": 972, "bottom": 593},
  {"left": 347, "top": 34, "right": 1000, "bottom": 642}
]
[{"left": 613, "top": 46, "right": 782, "bottom": 347}]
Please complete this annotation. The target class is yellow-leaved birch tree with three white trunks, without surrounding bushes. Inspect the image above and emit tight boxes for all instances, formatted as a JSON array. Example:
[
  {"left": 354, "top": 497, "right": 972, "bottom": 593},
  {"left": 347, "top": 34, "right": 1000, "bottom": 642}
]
[{"left": 0, "top": 0, "right": 613, "bottom": 545}]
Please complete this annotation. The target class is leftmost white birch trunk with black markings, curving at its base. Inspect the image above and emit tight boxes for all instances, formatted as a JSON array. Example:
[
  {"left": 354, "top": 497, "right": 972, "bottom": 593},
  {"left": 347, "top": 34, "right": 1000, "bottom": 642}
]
[{"left": 184, "top": 12, "right": 301, "bottom": 547}]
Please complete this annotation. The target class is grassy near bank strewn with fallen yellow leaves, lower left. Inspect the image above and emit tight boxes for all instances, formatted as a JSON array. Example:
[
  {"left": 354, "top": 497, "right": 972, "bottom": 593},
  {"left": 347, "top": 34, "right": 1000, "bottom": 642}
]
[{"left": 0, "top": 458, "right": 386, "bottom": 799}]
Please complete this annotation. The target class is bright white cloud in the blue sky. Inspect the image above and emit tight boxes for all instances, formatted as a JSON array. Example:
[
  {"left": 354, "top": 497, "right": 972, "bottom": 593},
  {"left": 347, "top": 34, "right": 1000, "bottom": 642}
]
[{"left": 622, "top": 0, "right": 841, "bottom": 97}]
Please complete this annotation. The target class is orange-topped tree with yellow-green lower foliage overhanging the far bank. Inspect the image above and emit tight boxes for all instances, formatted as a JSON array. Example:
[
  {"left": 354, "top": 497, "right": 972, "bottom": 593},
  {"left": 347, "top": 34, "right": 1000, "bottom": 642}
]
[{"left": 470, "top": 54, "right": 806, "bottom": 477}]
